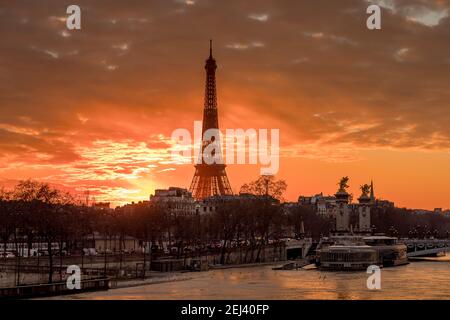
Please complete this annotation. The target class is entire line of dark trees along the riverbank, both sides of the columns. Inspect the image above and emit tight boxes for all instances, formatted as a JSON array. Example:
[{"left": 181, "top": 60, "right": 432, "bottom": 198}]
[{"left": 0, "top": 177, "right": 450, "bottom": 282}]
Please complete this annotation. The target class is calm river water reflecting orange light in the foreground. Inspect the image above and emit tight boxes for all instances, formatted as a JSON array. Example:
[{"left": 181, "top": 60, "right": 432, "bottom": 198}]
[{"left": 59, "top": 255, "right": 450, "bottom": 300}]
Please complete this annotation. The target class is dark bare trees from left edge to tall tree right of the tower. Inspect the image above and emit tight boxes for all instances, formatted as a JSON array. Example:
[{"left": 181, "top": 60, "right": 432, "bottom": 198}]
[{"left": 0, "top": 177, "right": 292, "bottom": 283}]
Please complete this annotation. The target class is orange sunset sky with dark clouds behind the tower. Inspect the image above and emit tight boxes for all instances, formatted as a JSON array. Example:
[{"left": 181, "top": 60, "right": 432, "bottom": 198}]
[{"left": 0, "top": 0, "right": 450, "bottom": 209}]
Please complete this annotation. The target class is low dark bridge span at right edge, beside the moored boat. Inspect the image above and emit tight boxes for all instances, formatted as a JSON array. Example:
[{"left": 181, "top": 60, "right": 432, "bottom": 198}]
[{"left": 398, "top": 239, "right": 450, "bottom": 257}]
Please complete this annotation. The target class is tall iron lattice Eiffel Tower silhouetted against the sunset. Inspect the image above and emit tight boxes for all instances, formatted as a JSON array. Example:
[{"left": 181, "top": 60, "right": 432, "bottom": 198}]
[{"left": 189, "top": 40, "right": 233, "bottom": 200}]
